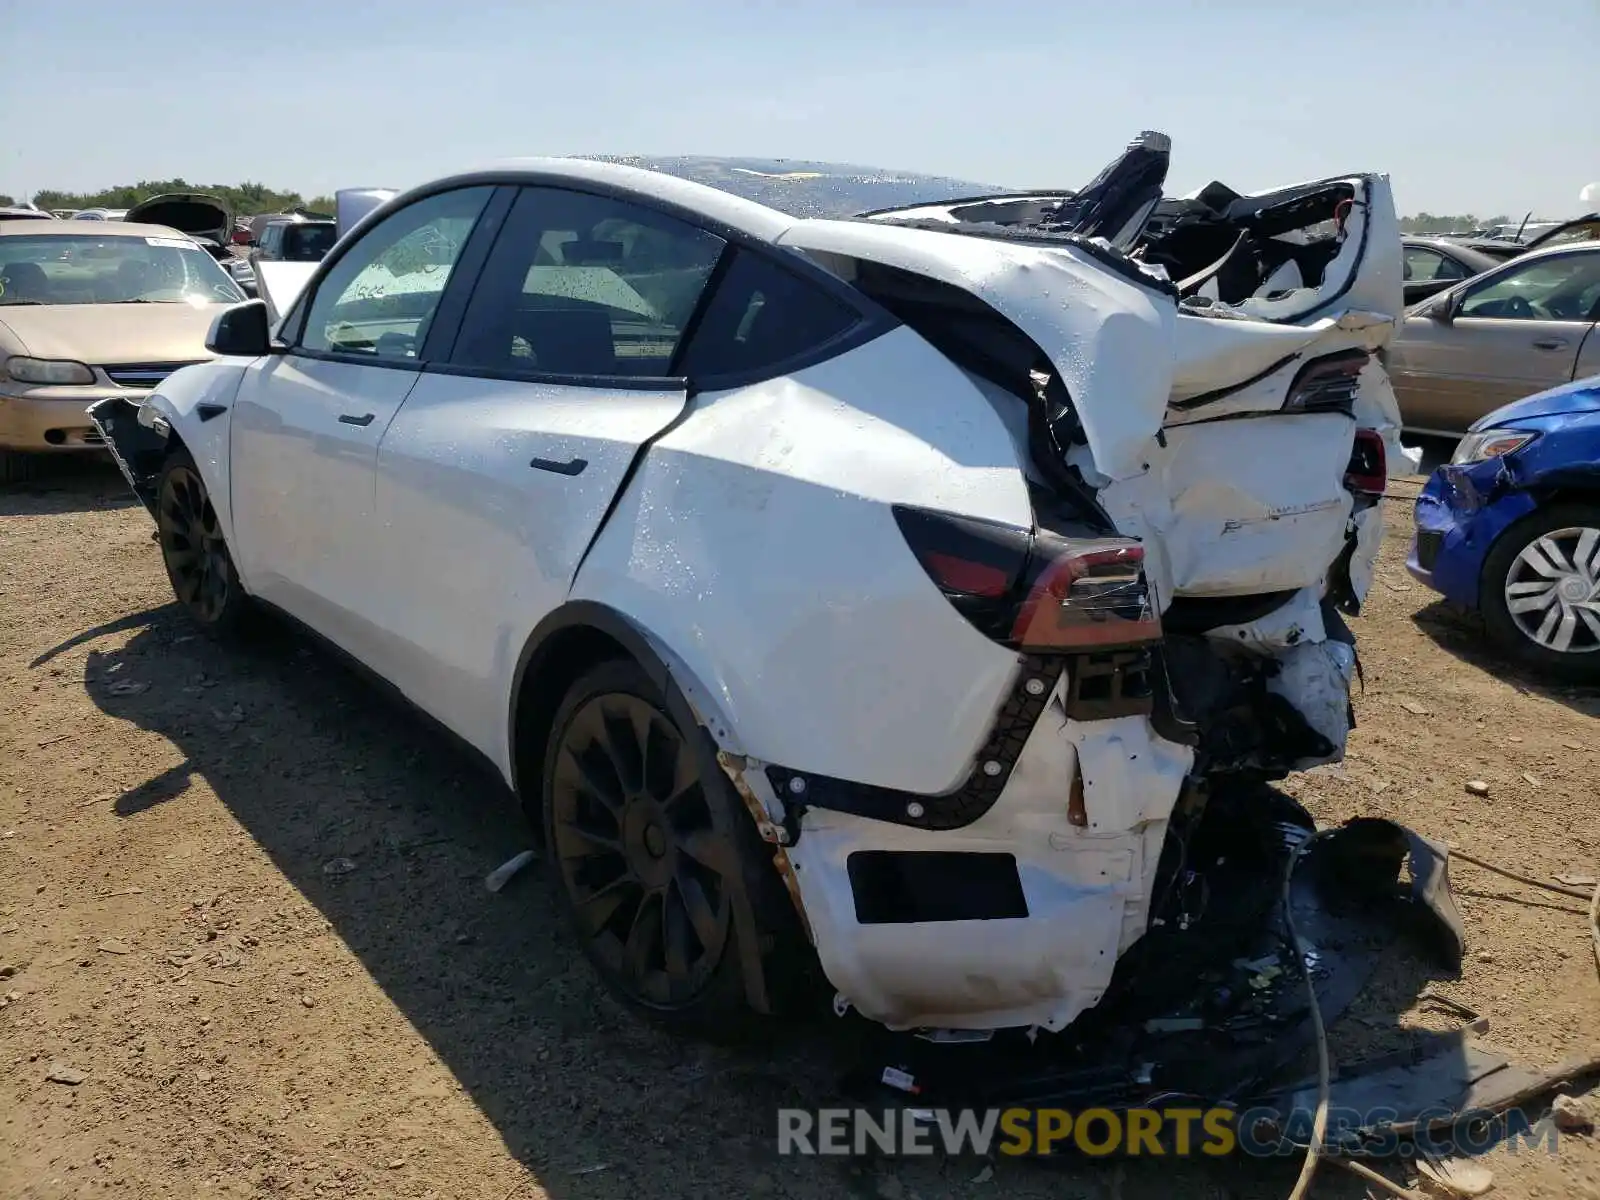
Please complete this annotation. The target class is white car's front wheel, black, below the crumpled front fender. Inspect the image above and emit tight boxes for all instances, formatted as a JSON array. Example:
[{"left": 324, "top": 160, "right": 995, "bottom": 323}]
[{"left": 155, "top": 448, "right": 250, "bottom": 637}]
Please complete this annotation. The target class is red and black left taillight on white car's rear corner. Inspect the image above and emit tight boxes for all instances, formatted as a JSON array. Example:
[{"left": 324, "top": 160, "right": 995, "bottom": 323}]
[{"left": 894, "top": 504, "right": 1162, "bottom": 654}]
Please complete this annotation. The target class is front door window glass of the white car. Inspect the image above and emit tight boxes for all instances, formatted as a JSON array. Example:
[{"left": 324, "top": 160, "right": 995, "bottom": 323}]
[{"left": 301, "top": 187, "right": 494, "bottom": 360}]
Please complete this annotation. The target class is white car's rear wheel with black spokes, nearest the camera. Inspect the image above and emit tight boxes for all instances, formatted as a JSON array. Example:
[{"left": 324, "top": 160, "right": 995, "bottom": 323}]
[{"left": 542, "top": 659, "right": 814, "bottom": 1042}]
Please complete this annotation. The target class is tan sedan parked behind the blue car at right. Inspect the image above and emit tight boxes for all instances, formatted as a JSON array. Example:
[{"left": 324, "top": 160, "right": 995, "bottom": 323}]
[{"left": 1389, "top": 242, "right": 1600, "bottom": 437}]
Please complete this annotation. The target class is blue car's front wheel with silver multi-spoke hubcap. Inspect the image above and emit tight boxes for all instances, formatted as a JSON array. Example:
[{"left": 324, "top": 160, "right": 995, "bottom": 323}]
[{"left": 1478, "top": 502, "right": 1600, "bottom": 682}]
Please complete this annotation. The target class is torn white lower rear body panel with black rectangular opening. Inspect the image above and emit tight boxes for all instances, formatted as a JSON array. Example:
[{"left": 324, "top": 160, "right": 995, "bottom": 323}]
[{"left": 768, "top": 677, "right": 1194, "bottom": 1030}]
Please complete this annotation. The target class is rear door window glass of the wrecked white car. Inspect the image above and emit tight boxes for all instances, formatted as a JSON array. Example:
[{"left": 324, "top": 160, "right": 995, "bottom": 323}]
[{"left": 450, "top": 187, "right": 723, "bottom": 376}]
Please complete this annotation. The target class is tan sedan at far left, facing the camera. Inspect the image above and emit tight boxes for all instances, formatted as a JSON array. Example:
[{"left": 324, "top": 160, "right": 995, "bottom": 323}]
[{"left": 0, "top": 221, "right": 245, "bottom": 482}]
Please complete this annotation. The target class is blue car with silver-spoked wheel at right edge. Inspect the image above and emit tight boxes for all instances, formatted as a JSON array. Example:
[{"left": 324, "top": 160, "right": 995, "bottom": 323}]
[{"left": 1406, "top": 374, "right": 1600, "bottom": 682}]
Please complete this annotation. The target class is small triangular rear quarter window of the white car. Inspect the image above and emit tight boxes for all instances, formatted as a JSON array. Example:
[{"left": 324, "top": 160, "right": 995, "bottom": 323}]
[{"left": 682, "top": 250, "right": 861, "bottom": 379}]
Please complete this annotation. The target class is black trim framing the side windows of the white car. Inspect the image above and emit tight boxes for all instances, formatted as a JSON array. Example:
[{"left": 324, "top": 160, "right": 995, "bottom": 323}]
[{"left": 379, "top": 171, "right": 901, "bottom": 395}]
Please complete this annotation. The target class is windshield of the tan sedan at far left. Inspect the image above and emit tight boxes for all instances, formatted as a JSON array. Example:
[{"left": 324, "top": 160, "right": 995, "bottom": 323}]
[{"left": 0, "top": 234, "right": 245, "bottom": 307}]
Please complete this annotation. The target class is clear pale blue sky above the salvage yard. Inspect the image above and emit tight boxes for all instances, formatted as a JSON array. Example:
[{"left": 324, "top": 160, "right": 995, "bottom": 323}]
[{"left": 0, "top": 0, "right": 1600, "bottom": 216}]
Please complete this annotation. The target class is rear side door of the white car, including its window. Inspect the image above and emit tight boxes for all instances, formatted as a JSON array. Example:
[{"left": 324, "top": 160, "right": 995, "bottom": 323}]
[{"left": 368, "top": 187, "right": 725, "bottom": 762}]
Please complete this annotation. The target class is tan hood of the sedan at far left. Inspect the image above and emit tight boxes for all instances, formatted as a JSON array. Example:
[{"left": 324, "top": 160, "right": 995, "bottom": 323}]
[{"left": 0, "top": 304, "right": 229, "bottom": 365}]
